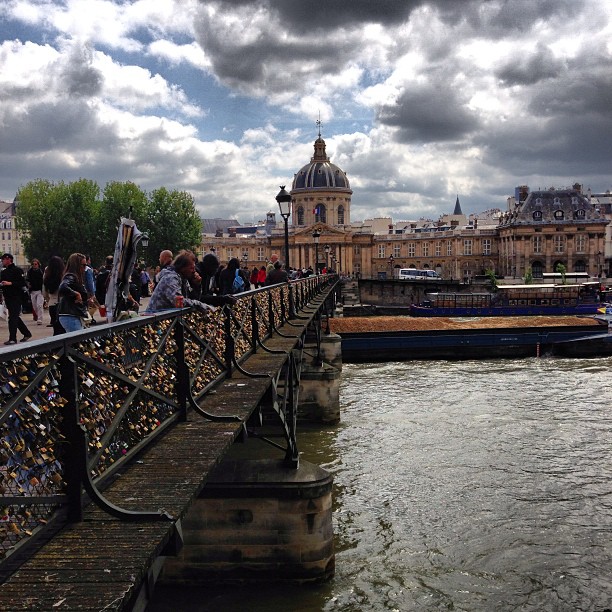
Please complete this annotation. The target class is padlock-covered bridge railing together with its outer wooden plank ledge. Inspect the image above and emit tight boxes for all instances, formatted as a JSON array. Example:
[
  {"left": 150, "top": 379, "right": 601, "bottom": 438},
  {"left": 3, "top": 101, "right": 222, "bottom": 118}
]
[{"left": 0, "top": 278, "right": 334, "bottom": 610}]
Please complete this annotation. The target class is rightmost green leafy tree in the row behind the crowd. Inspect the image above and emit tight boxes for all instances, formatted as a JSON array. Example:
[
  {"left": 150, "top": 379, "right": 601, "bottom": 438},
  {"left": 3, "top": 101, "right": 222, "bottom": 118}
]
[{"left": 145, "top": 187, "right": 202, "bottom": 265}]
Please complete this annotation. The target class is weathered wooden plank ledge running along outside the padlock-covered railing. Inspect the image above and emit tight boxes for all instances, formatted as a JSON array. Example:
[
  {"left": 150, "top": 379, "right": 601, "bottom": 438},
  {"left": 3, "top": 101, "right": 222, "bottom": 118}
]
[{"left": 0, "top": 298, "right": 322, "bottom": 612}]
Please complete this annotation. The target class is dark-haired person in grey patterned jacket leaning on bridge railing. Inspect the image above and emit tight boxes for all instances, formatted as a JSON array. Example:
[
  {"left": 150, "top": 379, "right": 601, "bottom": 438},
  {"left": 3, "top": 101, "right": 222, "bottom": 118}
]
[{"left": 145, "top": 251, "right": 215, "bottom": 314}]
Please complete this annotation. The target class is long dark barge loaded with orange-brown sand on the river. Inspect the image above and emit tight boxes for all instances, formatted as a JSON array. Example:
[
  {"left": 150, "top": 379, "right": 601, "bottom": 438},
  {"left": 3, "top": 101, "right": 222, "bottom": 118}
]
[{"left": 329, "top": 316, "right": 612, "bottom": 363}]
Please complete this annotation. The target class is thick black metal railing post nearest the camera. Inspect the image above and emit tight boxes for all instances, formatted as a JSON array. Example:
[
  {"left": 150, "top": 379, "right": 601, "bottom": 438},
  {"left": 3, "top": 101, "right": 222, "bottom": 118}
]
[{"left": 59, "top": 353, "right": 87, "bottom": 523}]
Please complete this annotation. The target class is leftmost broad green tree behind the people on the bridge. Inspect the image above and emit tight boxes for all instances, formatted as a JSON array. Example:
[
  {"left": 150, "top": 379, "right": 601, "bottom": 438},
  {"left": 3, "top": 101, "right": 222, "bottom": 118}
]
[{"left": 16, "top": 179, "right": 100, "bottom": 265}]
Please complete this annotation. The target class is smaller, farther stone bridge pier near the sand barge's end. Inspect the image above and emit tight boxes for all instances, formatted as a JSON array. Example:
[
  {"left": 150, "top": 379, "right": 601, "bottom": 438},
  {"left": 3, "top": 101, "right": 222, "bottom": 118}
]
[{"left": 298, "top": 334, "right": 342, "bottom": 424}]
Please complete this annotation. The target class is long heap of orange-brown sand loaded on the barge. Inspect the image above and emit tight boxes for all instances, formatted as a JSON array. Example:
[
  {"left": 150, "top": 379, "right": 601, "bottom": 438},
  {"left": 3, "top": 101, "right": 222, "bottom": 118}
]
[{"left": 329, "top": 316, "right": 599, "bottom": 334}]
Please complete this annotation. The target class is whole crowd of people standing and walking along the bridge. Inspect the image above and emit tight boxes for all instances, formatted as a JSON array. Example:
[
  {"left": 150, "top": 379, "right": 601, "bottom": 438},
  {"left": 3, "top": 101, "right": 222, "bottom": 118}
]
[{"left": 0, "top": 250, "right": 314, "bottom": 345}]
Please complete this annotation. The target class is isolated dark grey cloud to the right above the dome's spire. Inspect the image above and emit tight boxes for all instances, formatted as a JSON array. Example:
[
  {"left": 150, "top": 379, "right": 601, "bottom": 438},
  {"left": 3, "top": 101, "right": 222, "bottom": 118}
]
[{"left": 377, "top": 86, "right": 478, "bottom": 143}]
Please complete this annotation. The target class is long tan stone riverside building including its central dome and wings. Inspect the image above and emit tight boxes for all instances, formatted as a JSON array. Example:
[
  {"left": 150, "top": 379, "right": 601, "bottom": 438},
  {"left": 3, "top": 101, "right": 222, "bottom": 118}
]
[{"left": 202, "top": 134, "right": 612, "bottom": 280}]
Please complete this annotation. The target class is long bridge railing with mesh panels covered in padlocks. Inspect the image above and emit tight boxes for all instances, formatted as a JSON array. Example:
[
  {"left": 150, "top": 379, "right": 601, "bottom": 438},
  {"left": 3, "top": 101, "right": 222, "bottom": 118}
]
[{"left": 0, "top": 275, "right": 337, "bottom": 559}]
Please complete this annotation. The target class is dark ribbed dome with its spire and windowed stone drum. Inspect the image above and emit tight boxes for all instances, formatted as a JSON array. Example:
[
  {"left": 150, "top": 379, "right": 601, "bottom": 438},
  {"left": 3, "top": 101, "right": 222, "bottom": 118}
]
[{"left": 291, "top": 132, "right": 353, "bottom": 227}]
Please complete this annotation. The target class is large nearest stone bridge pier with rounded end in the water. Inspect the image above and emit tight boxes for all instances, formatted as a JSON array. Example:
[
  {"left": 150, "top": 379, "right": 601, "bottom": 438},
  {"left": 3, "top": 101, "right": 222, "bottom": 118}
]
[{"left": 161, "top": 459, "right": 335, "bottom": 584}]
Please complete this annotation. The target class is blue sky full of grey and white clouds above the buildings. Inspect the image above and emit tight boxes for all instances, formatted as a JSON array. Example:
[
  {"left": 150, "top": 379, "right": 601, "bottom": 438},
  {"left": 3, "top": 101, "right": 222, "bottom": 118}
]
[{"left": 0, "top": 0, "right": 612, "bottom": 223}]
